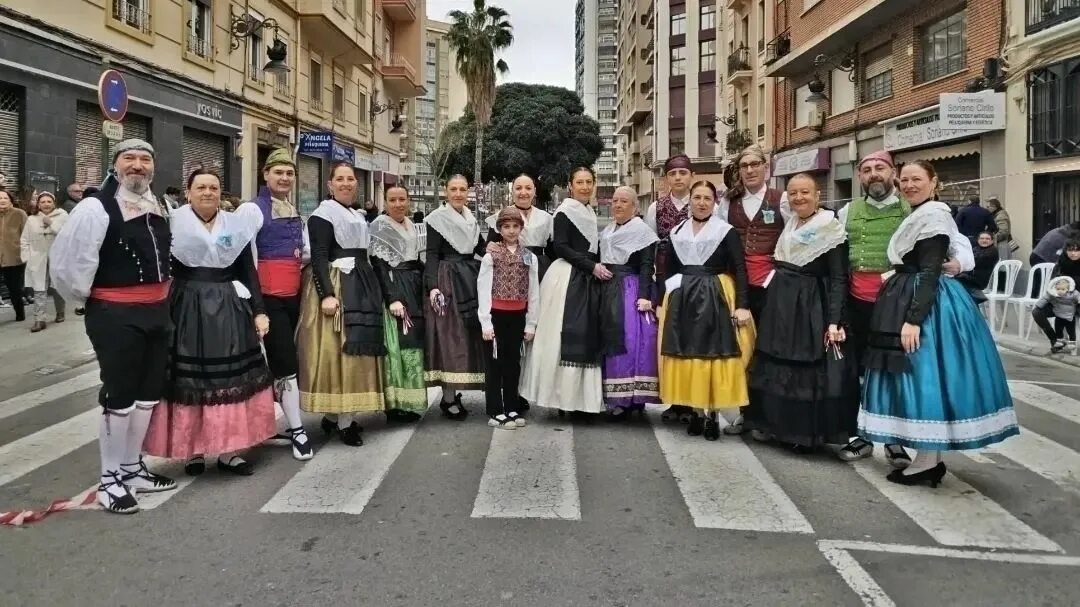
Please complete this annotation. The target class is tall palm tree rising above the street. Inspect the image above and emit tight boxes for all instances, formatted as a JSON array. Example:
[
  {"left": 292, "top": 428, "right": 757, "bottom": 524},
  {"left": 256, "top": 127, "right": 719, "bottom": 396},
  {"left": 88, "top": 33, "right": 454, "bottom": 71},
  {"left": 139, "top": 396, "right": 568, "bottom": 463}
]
[{"left": 447, "top": 0, "right": 514, "bottom": 189}]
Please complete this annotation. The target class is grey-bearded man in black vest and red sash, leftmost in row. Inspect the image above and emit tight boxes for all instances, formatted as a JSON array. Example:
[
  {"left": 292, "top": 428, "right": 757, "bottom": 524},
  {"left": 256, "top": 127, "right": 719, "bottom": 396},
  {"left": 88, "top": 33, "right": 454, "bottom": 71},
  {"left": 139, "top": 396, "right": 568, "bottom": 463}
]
[{"left": 49, "top": 139, "right": 176, "bottom": 514}]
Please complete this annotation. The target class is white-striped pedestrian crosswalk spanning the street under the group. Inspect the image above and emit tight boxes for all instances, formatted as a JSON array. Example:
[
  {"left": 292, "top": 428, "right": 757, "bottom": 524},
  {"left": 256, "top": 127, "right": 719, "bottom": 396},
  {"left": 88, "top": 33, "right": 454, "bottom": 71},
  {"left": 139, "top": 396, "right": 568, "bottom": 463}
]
[{"left": 0, "top": 373, "right": 1080, "bottom": 554}]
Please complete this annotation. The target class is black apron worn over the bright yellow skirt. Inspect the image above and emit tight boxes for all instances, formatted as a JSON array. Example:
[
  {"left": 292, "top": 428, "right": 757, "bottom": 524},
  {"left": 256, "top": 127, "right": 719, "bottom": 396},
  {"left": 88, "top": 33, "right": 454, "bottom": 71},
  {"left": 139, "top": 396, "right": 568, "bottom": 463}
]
[{"left": 661, "top": 266, "right": 742, "bottom": 359}]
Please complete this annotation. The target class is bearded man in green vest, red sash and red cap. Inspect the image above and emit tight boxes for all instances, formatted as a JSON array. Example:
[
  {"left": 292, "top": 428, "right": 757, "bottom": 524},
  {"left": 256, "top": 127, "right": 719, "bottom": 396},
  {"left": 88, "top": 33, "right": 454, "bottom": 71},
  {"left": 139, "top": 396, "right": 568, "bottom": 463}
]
[{"left": 837, "top": 150, "right": 975, "bottom": 462}]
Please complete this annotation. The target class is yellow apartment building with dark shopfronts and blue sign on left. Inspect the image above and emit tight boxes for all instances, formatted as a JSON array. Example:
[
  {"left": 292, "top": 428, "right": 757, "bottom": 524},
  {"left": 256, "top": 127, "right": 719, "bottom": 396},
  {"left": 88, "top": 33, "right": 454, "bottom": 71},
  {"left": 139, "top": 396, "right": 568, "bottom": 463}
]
[{"left": 0, "top": 0, "right": 424, "bottom": 213}]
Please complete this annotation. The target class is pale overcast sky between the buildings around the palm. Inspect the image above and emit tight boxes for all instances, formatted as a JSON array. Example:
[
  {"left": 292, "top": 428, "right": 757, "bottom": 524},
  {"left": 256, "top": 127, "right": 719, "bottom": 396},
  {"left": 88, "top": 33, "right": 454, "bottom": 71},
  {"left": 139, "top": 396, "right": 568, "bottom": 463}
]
[{"left": 428, "top": 0, "right": 575, "bottom": 91}]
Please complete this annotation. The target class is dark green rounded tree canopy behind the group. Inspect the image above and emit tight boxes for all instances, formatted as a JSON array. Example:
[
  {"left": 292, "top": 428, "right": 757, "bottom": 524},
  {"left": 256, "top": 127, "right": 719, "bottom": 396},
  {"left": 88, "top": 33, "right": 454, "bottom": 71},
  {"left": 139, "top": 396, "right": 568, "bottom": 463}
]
[{"left": 440, "top": 82, "right": 604, "bottom": 202}]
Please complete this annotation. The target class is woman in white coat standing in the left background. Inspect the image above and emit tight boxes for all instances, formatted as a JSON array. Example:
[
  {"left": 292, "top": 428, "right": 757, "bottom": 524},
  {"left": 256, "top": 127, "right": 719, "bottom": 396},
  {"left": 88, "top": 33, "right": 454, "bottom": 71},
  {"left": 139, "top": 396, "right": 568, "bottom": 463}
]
[{"left": 19, "top": 192, "right": 68, "bottom": 333}]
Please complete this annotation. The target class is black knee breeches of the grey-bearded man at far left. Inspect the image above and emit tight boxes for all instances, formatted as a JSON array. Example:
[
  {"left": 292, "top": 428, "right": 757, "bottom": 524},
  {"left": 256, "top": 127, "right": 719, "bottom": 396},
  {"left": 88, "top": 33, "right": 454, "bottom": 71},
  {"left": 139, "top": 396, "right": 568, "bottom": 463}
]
[{"left": 85, "top": 299, "right": 173, "bottom": 409}]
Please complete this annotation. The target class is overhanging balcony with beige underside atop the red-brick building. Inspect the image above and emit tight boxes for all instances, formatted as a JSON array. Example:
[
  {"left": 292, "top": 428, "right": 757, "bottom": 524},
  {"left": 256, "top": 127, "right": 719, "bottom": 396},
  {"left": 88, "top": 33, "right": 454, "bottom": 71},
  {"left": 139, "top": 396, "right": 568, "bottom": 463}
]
[{"left": 766, "top": 0, "right": 920, "bottom": 78}]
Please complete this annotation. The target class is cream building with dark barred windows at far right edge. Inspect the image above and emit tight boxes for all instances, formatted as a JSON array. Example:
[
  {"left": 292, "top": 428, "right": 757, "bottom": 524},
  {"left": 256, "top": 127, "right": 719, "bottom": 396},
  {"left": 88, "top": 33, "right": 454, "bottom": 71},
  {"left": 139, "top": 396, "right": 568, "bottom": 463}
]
[{"left": 996, "top": 0, "right": 1080, "bottom": 259}]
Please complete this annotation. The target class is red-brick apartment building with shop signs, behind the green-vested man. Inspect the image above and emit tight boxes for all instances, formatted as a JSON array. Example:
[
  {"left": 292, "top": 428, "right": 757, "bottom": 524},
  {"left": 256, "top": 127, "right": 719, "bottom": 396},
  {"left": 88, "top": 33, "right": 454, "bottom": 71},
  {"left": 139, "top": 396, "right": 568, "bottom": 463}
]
[{"left": 766, "top": 0, "right": 1005, "bottom": 206}]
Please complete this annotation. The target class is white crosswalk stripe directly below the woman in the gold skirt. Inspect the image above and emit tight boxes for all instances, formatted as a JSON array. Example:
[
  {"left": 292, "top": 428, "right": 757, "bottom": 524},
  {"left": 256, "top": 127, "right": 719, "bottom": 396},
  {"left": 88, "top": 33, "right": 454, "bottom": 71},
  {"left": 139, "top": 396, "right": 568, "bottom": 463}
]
[{"left": 259, "top": 414, "right": 417, "bottom": 514}]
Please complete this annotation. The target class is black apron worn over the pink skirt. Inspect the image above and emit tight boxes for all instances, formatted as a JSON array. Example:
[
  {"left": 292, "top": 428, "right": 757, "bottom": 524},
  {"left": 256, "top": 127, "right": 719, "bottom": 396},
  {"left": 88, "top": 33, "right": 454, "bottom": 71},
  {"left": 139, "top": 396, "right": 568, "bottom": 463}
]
[{"left": 165, "top": 268, "right": 272, "bottom": 405}]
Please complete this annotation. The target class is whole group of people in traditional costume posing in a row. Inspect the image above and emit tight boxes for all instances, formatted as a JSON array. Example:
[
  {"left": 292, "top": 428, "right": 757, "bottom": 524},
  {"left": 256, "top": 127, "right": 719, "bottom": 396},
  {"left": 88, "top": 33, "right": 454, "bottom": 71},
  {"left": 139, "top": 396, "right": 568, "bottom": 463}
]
[{"left": 50, "top": 139, "right": 1018, "bottom": 513}]
